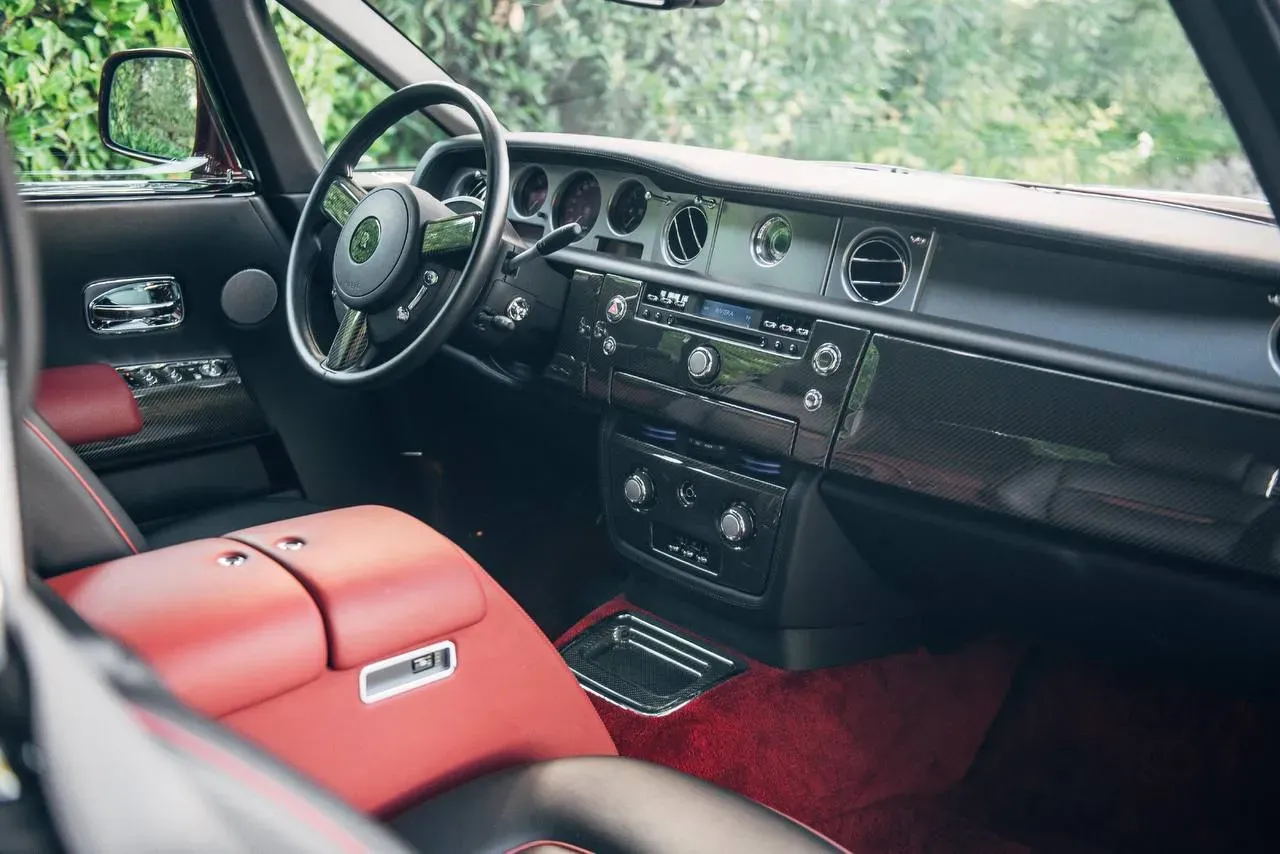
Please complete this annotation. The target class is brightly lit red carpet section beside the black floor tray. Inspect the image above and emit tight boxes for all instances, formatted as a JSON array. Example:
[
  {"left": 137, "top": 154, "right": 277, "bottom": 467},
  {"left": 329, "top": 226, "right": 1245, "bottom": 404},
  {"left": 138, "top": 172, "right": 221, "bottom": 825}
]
[{"left": 559, "top": 600, "right": 1023, "bottom": 850}]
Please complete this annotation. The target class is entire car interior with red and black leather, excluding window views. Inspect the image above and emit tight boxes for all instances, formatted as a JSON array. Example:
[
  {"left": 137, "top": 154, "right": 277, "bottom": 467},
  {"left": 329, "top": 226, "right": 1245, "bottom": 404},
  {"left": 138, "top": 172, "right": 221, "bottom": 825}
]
[{"left": 0, "top": 0, "right": 1280, "bottom": 854}]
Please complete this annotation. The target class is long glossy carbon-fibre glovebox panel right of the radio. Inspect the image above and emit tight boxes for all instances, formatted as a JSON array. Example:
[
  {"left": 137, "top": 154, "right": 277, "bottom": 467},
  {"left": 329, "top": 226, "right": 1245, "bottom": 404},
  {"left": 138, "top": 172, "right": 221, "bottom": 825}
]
[{"left": 831, "top": 335, "right": 1280, "bottom": 575}]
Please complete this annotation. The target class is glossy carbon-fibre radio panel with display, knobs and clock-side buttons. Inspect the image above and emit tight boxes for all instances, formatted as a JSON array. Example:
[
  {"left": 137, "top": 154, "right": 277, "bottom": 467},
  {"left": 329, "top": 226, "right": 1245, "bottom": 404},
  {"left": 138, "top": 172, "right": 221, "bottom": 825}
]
[{"left": 578, "top": 270, "right": 869, "bottom": 463}]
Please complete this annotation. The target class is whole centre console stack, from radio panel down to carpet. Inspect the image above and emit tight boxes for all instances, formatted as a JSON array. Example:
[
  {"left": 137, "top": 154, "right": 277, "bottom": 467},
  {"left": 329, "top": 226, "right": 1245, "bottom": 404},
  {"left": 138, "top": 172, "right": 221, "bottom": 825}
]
[{"left": 545, "top": 270, "right": 914, "bottom": 667}]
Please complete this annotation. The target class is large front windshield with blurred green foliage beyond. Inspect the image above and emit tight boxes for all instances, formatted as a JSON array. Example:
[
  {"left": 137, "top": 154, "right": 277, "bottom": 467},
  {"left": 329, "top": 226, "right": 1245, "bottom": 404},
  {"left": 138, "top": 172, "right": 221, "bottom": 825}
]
[{"left": 367, "top": 0, "right": 1262, "bottom": 198}]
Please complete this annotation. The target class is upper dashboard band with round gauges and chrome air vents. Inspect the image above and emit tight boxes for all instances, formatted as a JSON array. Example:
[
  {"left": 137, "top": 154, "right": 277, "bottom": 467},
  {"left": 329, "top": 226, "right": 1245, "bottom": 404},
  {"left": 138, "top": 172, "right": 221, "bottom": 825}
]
[{"left": 433, "top": 142, "right": 1280, "bottom": 391}]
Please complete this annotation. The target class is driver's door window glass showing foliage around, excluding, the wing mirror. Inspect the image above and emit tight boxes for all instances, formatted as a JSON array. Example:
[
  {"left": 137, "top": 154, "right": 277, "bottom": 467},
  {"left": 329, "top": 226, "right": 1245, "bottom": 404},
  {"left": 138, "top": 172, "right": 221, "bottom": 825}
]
[{"left": 0, "top": 0, "right": 191, "bottom": 182}]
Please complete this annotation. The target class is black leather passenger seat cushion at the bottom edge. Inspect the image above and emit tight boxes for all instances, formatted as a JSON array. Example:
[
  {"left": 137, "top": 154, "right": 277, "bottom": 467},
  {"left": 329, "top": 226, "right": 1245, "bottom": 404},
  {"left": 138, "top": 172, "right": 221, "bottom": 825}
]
[{"left": 392, "top": 745, "right": 844, "bottom": 854}]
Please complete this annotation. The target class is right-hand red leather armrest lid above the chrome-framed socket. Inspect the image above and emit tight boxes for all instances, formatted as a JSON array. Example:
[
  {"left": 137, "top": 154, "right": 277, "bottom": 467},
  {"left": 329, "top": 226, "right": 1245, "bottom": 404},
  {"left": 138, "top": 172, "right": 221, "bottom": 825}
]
[{"left": 228, "top": 507, "right": 486, "bottom": 670}]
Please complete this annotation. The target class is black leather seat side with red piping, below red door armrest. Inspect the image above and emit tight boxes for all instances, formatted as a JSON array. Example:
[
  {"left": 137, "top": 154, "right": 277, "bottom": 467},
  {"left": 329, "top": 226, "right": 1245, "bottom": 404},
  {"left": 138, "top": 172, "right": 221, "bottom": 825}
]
[{"left": 17, "top": 412, "right": 147, "bottom": 576}]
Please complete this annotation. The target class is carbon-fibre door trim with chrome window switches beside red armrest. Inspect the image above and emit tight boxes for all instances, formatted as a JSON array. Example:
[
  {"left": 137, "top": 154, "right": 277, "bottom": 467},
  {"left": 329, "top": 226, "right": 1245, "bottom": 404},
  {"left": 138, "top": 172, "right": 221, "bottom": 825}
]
[{"left": 76, "top": 360, "right": 270, "bottom": 469}]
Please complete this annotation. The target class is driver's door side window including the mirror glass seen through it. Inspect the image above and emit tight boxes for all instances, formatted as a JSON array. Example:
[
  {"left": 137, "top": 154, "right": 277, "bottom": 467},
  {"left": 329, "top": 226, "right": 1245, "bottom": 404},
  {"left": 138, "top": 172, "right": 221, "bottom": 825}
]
[{"left": 0, "top": 0, "right": 229, "bottom": 183}]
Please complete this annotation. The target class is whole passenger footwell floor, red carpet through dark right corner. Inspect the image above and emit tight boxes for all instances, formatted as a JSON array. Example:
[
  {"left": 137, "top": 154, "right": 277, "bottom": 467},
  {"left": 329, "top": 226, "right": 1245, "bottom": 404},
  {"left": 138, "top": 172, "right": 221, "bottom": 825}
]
[{"left": 562, "top": 602, "right": 1280, "bottom": 854}]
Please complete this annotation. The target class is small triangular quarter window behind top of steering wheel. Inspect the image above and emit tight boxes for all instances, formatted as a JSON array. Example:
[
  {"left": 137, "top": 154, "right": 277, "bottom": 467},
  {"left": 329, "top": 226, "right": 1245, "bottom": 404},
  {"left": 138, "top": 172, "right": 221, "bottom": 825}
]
[{"left": 269, "top": 0, "right": 448, "bottom": 169}]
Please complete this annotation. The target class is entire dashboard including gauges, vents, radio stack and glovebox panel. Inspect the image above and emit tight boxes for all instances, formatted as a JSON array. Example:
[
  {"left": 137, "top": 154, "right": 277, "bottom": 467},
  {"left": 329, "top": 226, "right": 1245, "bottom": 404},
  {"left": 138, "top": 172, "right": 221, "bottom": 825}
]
[{"left": 415, "top": 134, "right": 1280, "bottom": 665}]
